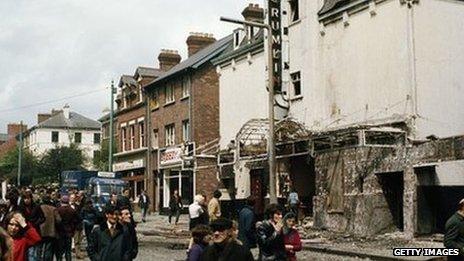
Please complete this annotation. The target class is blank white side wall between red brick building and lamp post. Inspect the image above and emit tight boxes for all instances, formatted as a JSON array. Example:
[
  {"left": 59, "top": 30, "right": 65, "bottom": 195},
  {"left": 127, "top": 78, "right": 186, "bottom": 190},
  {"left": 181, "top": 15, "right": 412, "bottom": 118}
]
[{"left": 219, "top": 50, "right": 268, "bottom": 148}]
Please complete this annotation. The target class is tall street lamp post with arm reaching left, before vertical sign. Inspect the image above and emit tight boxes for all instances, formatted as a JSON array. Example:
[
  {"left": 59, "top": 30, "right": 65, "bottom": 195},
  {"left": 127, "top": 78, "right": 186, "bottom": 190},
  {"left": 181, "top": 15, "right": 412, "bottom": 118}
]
[{"left": 220, "top": 17, "right": 277, "bottom": 204}]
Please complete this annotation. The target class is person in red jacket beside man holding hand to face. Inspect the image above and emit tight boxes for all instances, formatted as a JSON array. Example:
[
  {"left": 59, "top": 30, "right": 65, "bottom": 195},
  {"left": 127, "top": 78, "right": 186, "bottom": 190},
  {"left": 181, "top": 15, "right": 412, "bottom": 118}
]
[{"left": 283, "top": 212, "right": 302, "bottom": 261}]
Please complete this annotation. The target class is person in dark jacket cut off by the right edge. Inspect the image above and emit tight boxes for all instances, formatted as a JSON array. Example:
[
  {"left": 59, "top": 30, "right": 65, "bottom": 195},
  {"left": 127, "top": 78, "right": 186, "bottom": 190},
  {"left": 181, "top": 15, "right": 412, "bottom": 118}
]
[{"left": 443, "top": 199, "right": 464, "bottom": 260}]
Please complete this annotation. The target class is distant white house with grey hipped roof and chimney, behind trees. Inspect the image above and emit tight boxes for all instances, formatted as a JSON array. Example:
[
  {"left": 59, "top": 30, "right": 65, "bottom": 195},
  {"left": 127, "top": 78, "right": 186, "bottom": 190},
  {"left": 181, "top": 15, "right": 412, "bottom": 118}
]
[{"left": 24, "top": 106, "right": 101, "bottom": 168}]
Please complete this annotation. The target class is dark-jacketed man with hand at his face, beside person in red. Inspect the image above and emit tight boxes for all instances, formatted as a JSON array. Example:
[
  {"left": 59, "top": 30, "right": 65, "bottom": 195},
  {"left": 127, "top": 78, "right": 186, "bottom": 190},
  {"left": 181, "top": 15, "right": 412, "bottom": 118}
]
[{"left": 256, "top": 204, "right": 287, "bottom": 261}]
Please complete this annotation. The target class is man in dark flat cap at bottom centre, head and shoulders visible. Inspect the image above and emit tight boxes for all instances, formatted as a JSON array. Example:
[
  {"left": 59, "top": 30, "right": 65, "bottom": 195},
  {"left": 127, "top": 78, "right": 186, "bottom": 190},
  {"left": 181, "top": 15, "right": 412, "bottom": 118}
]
[{"left": 200, "top": 218, "right": 254, "bottom": 261}]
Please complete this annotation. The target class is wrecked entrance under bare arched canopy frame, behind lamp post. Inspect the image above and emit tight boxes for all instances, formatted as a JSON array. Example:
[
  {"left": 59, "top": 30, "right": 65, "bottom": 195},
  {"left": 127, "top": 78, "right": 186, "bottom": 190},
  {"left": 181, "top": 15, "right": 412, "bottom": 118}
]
[{"left": 218, "top": 119, "right": 315, "bottom": 217}]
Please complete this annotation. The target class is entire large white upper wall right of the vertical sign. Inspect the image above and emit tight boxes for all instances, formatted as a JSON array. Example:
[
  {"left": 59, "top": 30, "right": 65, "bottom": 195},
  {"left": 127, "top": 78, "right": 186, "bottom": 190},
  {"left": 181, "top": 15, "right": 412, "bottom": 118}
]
[{"left": 286, "top": 0, "right": 464, "bottom": 139}]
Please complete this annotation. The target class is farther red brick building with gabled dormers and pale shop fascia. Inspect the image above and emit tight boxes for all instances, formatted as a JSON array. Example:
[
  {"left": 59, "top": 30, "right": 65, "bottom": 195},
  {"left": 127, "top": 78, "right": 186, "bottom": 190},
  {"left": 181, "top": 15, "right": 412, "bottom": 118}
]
[{"left": 111, "top": 67, "right": 161, "bottom": 199}]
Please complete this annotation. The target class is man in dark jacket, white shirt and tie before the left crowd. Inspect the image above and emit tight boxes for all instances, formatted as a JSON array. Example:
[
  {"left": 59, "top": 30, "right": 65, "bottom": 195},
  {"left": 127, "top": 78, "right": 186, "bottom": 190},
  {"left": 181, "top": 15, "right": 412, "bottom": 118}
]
[{"left": 87, "top": 206, "right": 132, "bottom": 261}]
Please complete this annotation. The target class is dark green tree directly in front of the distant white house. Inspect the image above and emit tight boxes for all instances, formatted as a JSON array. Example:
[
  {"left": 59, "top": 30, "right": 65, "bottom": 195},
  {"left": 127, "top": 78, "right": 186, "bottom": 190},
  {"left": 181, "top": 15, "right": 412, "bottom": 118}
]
[{"left": 39, "top": 144, "right": 86, "bottom": 183}]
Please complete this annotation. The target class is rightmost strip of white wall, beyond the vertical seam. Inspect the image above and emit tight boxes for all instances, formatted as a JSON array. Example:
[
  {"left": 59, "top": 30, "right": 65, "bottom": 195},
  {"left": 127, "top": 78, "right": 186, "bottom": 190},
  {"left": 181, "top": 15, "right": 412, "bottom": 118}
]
[{"left": 414, "top": 0, "right": 464, "bottom": 137}]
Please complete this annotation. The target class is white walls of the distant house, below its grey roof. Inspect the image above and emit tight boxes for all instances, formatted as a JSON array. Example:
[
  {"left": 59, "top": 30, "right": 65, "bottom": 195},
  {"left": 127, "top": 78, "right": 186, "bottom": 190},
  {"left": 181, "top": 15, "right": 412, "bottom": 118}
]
[{"left": 27, "top": 129, "right": 101, "bottom": 168}]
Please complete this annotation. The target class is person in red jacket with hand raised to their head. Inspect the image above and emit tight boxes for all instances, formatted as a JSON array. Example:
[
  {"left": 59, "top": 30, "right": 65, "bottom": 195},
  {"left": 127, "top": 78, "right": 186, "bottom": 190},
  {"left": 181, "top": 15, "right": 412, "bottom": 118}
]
[{"left": 7, "top": 212, "right": 41, "bottom": 261}]
